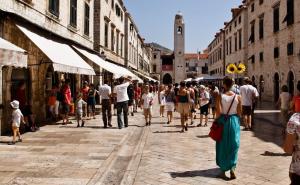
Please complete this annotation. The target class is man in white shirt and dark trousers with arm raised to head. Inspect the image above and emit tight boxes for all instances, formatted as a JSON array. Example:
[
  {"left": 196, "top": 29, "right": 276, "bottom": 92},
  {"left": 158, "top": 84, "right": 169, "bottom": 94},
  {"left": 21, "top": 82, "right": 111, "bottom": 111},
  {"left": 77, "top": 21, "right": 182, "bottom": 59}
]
[{"left": 114, "top": 77, "right": 130, "bottom": 129}]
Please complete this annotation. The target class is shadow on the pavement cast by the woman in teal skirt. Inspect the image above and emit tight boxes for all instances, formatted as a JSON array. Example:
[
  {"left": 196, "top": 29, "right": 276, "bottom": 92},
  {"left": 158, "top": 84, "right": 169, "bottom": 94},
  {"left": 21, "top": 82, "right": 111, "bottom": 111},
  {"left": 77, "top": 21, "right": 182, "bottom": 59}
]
[{"left": 169, "top": 168, "right": 221, "bottom": 178}]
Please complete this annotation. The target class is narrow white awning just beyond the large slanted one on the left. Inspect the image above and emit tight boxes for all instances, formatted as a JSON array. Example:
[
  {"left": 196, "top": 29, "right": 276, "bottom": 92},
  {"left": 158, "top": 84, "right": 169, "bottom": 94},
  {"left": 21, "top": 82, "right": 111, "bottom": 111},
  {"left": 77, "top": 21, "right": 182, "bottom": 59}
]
[{"left": 73, "top": 46, "right": 143, "bottom": 82}]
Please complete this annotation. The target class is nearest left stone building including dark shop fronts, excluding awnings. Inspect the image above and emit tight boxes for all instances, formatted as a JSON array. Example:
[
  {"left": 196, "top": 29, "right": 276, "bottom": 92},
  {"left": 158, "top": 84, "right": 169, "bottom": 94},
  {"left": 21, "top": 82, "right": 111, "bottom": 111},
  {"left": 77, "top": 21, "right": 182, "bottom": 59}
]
[{"left": 0, "top": 0, "right": 94, "bottom": 133}]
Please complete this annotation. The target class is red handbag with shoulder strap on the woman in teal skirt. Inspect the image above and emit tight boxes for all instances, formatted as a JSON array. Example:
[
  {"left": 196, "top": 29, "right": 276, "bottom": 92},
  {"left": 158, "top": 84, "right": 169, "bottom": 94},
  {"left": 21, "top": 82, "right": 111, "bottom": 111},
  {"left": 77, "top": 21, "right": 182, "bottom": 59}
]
[{"left": 208, "top": 95, "right": 236, "bottom": 142}]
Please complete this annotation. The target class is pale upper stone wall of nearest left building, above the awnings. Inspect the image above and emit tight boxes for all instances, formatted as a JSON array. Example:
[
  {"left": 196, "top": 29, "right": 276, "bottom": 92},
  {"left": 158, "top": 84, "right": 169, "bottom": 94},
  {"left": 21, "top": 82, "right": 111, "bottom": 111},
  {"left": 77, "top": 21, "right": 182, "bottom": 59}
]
[{"left": 0, "top": 0, "right": 94, "bottom": 49}]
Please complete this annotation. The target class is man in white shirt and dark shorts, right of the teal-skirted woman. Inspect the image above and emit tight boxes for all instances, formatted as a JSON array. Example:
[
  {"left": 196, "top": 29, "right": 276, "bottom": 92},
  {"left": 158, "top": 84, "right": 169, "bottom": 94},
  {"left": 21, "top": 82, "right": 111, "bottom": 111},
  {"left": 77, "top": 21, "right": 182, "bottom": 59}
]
[{"left": 240, "top": 77, "right": 259, "bottom": 130}]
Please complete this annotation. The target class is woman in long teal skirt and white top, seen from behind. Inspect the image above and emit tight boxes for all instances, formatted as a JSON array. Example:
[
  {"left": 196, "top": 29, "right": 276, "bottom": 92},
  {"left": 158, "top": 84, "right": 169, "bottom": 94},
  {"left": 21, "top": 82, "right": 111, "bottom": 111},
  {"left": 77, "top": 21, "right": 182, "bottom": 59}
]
[{"left": 216, "top": 77, "right": 242, "bottom": 179}]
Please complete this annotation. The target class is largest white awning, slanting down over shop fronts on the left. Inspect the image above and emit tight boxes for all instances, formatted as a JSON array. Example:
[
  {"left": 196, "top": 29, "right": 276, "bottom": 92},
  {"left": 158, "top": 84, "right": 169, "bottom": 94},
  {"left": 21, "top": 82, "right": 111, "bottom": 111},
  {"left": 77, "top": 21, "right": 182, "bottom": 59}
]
[{"left": 17, "top": 25, "right": 95, "bottom": 75}]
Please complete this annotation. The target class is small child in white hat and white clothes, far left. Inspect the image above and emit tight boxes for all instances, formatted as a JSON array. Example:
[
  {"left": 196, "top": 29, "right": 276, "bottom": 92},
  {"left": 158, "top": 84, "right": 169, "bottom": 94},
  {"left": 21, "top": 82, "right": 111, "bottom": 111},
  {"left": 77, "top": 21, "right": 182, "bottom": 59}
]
[{"left": 9, "top": 100, "right": 25, "bottom": 145}]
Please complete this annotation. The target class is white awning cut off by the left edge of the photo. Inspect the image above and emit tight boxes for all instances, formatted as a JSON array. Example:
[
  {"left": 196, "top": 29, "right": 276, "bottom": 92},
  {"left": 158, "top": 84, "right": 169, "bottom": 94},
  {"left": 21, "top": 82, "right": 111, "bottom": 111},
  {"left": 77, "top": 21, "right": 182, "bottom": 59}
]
[{"left": 0, "top": 37, "right": 28, "bottom": 67}]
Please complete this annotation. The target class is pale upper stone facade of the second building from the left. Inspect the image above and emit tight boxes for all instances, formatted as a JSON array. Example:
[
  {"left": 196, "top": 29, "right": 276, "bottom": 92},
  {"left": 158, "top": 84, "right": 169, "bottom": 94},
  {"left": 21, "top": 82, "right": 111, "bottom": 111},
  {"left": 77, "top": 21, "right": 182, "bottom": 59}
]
[{"left": 94, "top": 0, "right": 126, "bottom": 65}]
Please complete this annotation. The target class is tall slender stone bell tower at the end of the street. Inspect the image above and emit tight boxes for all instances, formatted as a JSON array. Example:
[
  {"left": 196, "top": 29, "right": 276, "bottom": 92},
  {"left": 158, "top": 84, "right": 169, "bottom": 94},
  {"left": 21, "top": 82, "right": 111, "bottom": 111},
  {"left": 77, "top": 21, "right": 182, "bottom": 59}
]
[{"left": 173, "top": 12, "right": 186, "bottom": 83}]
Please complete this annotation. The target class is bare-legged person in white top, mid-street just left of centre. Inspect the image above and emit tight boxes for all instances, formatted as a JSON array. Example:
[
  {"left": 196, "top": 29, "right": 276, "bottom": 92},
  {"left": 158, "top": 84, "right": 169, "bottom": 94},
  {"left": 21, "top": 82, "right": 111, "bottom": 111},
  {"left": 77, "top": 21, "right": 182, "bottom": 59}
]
[{"left": 141, "top": 85, "right": 153, "bottom": 126}]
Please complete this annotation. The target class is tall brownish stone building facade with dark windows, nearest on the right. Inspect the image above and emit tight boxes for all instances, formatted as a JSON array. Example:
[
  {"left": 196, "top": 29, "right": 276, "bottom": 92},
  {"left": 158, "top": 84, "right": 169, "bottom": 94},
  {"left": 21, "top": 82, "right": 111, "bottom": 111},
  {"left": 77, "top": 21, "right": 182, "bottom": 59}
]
[{"left": 209, "top": 0, "right": 300, "bottom": 101}]
